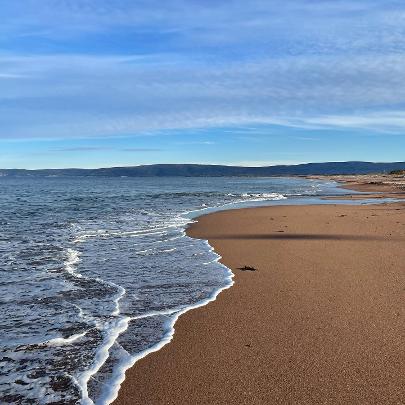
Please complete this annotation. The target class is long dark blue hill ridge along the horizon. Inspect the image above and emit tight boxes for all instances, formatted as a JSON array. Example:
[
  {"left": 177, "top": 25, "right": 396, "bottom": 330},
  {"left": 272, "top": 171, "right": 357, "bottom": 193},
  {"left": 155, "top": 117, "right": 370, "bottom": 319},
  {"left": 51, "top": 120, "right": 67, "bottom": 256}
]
[{"left": 0, "top": 162, "right": 405, "bottom": 177}]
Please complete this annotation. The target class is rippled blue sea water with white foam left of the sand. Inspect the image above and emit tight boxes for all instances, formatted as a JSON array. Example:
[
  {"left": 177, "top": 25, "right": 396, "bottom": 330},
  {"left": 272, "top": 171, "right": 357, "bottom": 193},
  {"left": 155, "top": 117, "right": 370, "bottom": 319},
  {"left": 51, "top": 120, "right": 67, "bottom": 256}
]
[{"left": 0, "top": 177, "right": 344, "bottom": 404}]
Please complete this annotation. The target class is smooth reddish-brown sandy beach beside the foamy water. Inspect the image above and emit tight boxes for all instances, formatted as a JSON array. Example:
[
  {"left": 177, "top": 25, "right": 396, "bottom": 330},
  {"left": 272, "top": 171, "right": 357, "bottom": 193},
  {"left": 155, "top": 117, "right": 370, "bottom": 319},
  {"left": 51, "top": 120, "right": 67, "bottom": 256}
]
[{"left": 115, "top": 185, "right": 405, "bottom": 405}]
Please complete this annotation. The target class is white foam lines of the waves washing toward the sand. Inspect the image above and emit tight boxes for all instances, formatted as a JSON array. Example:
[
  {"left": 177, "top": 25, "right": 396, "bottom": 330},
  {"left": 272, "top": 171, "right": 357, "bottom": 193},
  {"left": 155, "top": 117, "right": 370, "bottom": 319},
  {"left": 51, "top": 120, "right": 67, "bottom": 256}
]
[{"left": 67, "top": 193, "right": 287, "bottom": 405}]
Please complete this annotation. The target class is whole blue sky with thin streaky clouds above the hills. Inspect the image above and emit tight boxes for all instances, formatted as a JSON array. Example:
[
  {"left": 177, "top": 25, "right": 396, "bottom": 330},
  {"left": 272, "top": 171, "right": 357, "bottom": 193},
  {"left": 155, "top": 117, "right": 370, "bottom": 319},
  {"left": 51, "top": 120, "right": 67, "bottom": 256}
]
[{"left": 0, "top": 0, "right": 405, "bottom": 169}]
